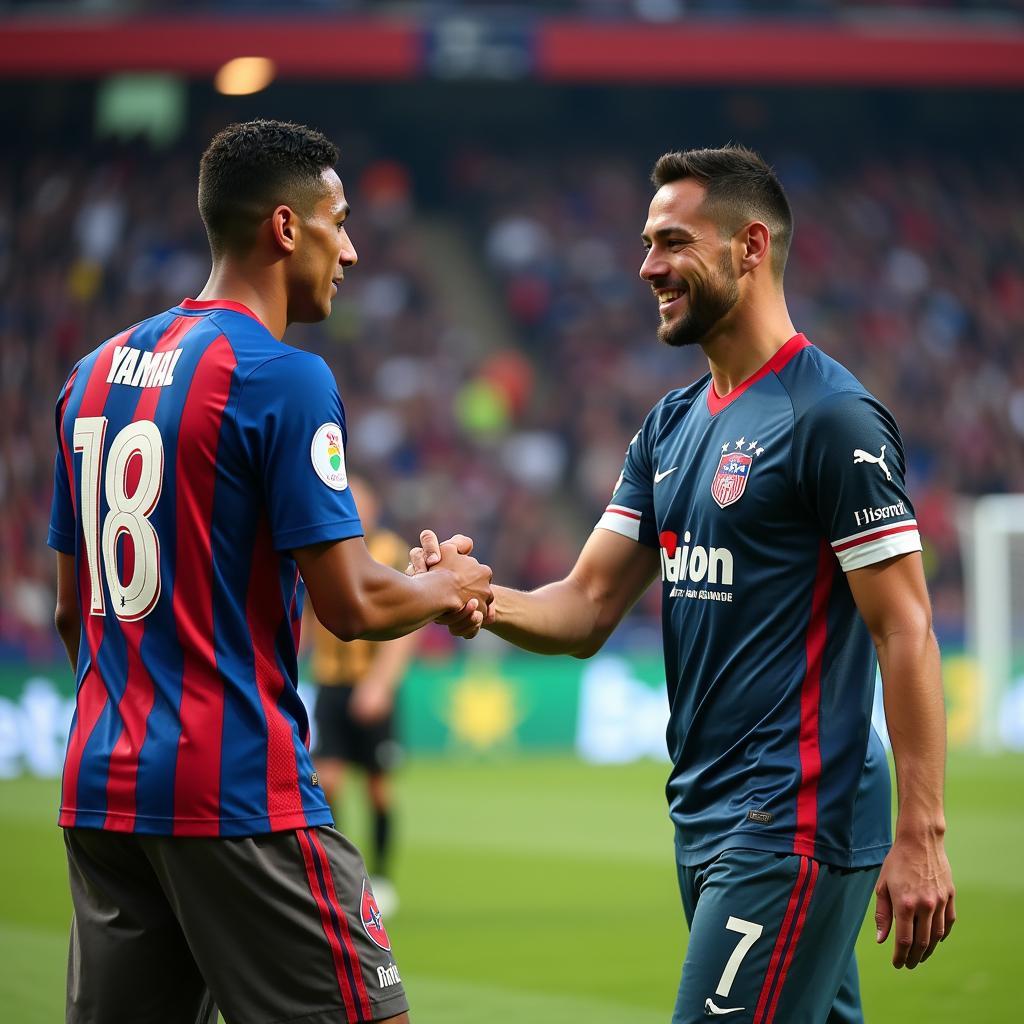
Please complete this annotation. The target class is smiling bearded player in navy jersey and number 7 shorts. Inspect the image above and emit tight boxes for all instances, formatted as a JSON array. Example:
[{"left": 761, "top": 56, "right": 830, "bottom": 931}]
[{"left": 411, "top": 146, "right": 954, "bottom": 1024}]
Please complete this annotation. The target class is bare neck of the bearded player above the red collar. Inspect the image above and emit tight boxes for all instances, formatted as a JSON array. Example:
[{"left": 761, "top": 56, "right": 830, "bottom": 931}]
[{"left": 700, "top": 294, "right": 797, "bottom": 398}]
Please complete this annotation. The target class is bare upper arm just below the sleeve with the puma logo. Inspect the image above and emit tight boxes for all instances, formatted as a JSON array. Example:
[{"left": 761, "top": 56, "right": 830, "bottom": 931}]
[{"left": 846, "top": 551, "right": 932, "bottom": 643}]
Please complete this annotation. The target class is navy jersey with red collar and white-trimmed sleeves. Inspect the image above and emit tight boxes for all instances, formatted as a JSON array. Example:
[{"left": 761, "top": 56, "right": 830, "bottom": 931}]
[{"left": 598, "top": 335, "right": 921, "bottom": 867}]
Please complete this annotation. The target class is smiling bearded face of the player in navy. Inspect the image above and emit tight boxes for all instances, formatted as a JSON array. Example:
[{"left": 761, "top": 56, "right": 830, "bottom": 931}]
[{"left": 640, "top": 178, "right": 739, "bottom": 346}]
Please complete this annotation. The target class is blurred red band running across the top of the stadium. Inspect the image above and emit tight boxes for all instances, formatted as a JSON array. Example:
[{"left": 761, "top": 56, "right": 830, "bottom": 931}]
[{"left": 0, "top": 16, "right": 1024, "bottom": 86}]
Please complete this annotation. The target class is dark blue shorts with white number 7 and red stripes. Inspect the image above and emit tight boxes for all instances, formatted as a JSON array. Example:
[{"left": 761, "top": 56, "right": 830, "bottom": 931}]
[{"left": 672, "top": 837, "right": 880, "bottom": 1024}]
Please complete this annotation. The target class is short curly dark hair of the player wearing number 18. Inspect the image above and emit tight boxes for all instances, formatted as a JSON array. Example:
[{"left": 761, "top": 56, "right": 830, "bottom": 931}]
[{"left": 199, "top": 120, "right": 338, "bottom": 256}]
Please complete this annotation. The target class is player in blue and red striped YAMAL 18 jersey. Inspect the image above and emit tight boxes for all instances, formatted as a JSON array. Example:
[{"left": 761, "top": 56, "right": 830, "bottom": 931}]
[{"left": 49, "top": 121, "right": 490, "bottom": 1024}]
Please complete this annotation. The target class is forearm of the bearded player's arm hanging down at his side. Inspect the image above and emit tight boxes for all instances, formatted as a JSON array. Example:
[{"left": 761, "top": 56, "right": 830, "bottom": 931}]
[{"left": 878, "top": 628, "right": 946, "bottom": 837}]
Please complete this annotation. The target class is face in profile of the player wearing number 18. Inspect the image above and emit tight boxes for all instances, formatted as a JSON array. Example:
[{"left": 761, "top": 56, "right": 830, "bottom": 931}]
[{"left": 288, "top": 169, "right": 358, "bottom": 324}]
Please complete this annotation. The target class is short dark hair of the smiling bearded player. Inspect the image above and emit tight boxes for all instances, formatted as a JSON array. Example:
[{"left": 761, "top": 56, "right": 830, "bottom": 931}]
[{"left": 650, "top": 144, "right": 793, "bottom": 278}]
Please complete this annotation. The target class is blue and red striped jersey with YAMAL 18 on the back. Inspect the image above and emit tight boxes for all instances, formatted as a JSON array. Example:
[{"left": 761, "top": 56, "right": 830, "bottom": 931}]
[{"left": 48, "top": 299, "right": 362, "bottom": 836}]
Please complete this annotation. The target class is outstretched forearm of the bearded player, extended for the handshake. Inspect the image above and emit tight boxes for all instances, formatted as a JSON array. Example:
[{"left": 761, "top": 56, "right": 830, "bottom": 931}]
[{"left": 486, "top": 577, "right": 606, "bottom": 656}]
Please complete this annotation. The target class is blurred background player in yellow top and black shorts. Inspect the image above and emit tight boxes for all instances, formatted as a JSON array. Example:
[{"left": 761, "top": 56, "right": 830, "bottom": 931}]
[{"left": 302, "top": 476, "right": 416, "bottom": 916}]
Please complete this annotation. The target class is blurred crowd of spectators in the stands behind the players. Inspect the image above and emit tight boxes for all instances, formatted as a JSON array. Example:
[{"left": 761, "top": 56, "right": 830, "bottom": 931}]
[{"left": 0, "top": 140, "right": 1024, "bottom": 656}]
